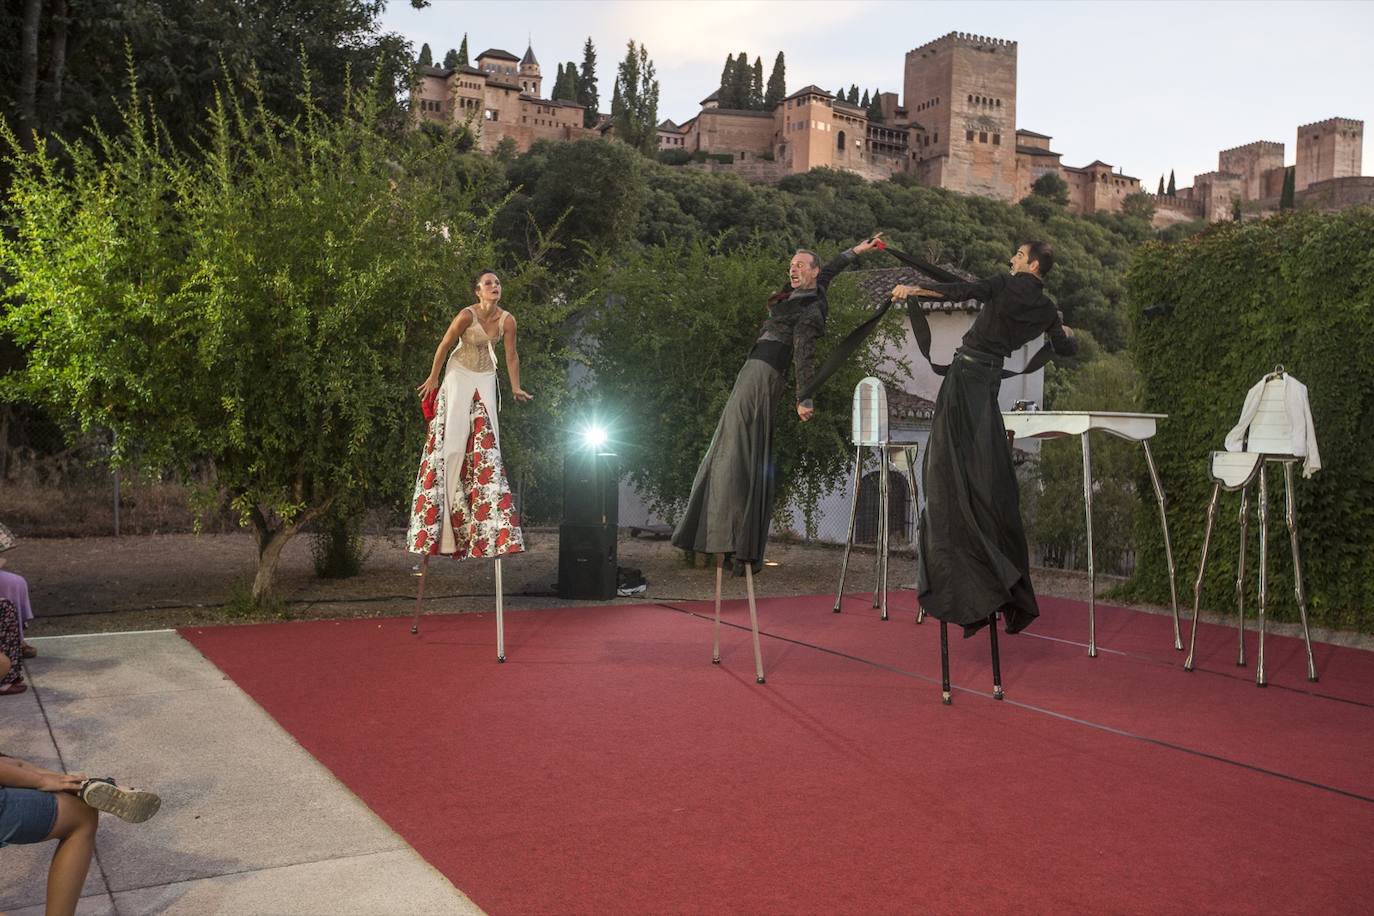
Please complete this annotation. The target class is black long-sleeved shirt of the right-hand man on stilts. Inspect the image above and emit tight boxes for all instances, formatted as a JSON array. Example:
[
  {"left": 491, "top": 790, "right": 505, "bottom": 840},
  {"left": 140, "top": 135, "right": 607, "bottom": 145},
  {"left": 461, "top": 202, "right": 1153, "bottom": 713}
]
[{"left": 922, "top": 273, "right": 1079, "bottom": 358}]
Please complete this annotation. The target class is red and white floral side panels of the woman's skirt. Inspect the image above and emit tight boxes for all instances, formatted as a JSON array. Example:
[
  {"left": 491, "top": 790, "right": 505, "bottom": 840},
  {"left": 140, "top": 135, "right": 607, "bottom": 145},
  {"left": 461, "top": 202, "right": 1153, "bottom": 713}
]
[{"left": 407, "top": 390, "right": 525, "bottom": 559}]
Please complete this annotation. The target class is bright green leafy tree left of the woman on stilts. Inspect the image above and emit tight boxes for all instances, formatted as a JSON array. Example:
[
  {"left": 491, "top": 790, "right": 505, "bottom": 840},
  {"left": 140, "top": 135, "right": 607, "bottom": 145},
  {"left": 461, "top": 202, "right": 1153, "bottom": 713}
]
[{"left": 0, "top": 67, "right": 526, "bottom": 602}]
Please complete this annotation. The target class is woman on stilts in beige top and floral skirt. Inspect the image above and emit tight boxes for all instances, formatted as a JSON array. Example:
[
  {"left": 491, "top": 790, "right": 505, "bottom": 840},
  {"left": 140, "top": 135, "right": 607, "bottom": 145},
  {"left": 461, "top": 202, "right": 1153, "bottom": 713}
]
[{"left": 407, "top": 271, "right": 533, "bottom": 662}]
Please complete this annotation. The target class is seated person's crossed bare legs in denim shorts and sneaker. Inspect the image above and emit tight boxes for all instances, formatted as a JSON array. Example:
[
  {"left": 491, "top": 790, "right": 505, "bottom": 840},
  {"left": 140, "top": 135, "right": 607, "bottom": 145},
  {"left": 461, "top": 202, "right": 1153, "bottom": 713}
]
[{"left": 0, "top": 754, "right": 162, "bottom": 916}]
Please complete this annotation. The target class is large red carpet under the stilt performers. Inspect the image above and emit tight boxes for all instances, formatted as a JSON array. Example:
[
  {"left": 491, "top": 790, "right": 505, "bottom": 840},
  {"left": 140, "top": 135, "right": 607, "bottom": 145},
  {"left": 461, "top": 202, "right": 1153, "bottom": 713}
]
[{"left": 183, "top": 593, "right": 1374, "bottom": 913}]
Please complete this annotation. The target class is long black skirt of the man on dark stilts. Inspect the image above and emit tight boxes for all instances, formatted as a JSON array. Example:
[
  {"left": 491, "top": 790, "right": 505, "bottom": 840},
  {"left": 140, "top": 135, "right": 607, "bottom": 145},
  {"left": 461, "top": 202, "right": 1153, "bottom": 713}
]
[{"left": 916, "top": 354, "right": 1040, "bottom": 636}]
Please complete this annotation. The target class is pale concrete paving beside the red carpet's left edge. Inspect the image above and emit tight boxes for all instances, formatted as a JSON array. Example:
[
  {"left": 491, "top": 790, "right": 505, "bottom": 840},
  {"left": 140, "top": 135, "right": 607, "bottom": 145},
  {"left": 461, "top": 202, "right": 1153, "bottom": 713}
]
[{"left": 0, "top": 630, "right": 481, "bottom": 916}]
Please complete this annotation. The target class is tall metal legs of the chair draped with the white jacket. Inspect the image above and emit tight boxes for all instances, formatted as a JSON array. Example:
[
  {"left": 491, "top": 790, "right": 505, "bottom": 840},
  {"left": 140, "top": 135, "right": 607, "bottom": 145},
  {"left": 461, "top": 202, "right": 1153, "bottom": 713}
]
[{"left": 1183, "top": 457, "right": 1318, "bottom": 687}]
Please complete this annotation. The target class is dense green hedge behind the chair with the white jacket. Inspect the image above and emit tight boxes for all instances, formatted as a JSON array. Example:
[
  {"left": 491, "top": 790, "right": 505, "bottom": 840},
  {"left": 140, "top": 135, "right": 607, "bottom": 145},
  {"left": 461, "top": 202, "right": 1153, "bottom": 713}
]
[{"left": 1127, "top": 207, "right": 1374, "bottom": 632}]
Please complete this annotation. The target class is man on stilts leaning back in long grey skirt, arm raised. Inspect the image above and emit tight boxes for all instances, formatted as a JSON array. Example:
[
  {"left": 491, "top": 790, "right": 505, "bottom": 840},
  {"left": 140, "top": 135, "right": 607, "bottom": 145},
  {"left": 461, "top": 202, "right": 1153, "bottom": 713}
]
[{"left": 672, "top": 233, "right": 881, "bottom": 684}]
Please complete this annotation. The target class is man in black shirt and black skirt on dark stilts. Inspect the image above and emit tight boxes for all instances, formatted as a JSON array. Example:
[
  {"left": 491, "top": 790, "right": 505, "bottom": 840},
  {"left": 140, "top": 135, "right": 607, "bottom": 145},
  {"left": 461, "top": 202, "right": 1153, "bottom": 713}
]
[{"left": 892, "top": 242, "right": 1079, "bottom": 703}]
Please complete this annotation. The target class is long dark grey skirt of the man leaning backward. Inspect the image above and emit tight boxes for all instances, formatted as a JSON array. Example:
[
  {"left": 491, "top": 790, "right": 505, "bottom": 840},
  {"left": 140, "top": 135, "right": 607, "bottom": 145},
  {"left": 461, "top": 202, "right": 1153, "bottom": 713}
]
[{"left": 672, "top": 360, "right": 783, "bottom": 570}]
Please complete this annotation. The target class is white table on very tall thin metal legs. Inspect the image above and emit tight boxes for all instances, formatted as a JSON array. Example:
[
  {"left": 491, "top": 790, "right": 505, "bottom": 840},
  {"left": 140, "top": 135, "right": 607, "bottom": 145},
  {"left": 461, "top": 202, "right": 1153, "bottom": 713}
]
[{"left": 1002, "top": 411, "right": 1183, "bottom": 658}]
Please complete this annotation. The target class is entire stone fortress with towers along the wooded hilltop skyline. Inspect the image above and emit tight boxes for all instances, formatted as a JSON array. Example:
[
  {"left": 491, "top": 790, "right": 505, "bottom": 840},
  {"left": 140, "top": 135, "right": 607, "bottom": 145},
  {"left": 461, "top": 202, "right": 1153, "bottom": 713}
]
[{"left": 412, "top": 32, "right": 1374, "bottom": 225}]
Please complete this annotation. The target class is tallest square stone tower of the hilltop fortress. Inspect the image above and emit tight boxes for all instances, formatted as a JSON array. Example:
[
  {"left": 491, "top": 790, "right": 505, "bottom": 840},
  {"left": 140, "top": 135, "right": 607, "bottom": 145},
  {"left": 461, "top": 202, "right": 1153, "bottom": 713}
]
[{"left": 903, "top": 32, "right": 1017, "bottom": 201}]
